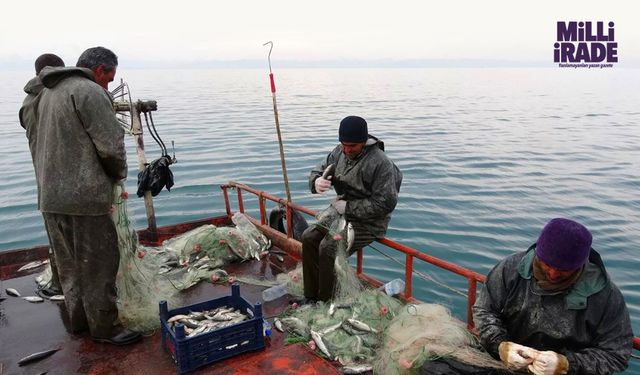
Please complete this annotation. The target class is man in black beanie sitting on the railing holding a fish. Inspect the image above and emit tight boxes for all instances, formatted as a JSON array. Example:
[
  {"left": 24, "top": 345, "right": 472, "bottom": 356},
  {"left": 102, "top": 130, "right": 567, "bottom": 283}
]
[{"left": 301, "top": 116, "right": 402, "bottom": 303}]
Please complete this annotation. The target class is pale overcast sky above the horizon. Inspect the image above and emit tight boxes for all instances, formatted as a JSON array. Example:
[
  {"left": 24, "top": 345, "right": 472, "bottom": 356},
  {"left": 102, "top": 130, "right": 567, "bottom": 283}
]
[{"left": 0, "top": 0, "right": 640, "bottom": 66}]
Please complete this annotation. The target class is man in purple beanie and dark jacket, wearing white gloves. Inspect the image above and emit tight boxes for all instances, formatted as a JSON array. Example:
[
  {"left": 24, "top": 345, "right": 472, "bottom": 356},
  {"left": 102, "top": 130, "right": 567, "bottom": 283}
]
[{"left": 473, "top": 218, "right": 633, "bottom": 375}]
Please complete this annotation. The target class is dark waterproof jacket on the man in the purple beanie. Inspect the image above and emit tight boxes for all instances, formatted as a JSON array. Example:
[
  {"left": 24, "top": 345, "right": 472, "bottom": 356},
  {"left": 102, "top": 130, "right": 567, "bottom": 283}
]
[{"left": 473, "top": 245, "right": 633, "bottom": 375}]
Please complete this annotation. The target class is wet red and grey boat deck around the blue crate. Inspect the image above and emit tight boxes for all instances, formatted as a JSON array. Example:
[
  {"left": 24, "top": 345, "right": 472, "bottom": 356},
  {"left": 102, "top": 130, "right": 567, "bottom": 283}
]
[{"left": 0, "top": 251, "right": 339, "bottom": 375}]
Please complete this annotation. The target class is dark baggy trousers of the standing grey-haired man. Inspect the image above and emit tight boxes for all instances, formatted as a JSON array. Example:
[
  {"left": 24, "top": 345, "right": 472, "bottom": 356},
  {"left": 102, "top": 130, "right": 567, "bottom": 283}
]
[{"left": 43, "top": 213, "right": 120, "bottom": 338}]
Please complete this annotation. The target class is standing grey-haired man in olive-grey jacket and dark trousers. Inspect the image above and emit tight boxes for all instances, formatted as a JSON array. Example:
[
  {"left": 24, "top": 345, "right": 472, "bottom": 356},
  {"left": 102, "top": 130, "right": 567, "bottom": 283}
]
[{"left": 30, "top": 47, "right": 141, "bottom": 345}]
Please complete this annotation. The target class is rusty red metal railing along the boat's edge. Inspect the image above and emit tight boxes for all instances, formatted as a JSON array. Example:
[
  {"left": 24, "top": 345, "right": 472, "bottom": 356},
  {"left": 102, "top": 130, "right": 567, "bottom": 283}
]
[{"left": 220, "top": 182, "right": 640, "bottom": 350}]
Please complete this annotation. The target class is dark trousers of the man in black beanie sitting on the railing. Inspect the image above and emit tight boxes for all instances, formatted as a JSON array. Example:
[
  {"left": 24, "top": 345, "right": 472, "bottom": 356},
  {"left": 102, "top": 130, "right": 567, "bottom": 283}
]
[{"left": 302, "top": 225, "right": 376, "bottom": 301}]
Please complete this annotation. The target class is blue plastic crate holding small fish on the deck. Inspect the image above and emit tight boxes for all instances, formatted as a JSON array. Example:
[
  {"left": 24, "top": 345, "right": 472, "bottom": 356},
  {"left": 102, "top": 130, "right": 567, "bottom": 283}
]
[{"left": 160, "top": 283, "right": 265, "bottom": 374}]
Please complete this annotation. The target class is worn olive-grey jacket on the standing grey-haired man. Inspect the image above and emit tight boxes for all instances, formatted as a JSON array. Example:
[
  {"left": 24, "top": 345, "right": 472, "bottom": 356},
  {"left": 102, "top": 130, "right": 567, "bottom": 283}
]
[{"left": 31, "top": 67, "right": 127, "bottom": 215}]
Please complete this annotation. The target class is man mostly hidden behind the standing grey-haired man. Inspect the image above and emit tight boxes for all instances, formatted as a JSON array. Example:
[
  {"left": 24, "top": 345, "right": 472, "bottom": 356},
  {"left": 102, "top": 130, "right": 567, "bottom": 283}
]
[{"left": 18, "top": 53, "right": 64, "bottom": 297}]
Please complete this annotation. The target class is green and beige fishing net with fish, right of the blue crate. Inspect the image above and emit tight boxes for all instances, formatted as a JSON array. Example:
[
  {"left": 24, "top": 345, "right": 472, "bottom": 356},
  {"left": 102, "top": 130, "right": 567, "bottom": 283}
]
[{"left": 276, "top": 207, "right": 503, "bottom": 374}]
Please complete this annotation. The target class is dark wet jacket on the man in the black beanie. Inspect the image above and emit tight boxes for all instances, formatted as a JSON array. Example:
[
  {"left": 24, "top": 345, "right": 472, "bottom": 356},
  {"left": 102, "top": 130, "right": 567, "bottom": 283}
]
[{"left": 309, "top": 136, "right": 402, "bottom": 238}]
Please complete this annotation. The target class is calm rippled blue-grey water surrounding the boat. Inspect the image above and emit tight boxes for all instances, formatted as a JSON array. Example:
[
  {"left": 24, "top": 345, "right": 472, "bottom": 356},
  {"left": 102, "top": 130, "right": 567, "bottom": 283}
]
[{"left": 0, "top": 68, "right": 640, "bottom": 373}]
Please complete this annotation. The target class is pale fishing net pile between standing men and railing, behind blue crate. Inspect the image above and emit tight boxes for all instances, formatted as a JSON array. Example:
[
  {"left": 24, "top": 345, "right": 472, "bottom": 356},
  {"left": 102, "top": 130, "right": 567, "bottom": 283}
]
[{"left": 36, "top": 184, "right": 271, "bottom": 332}]
